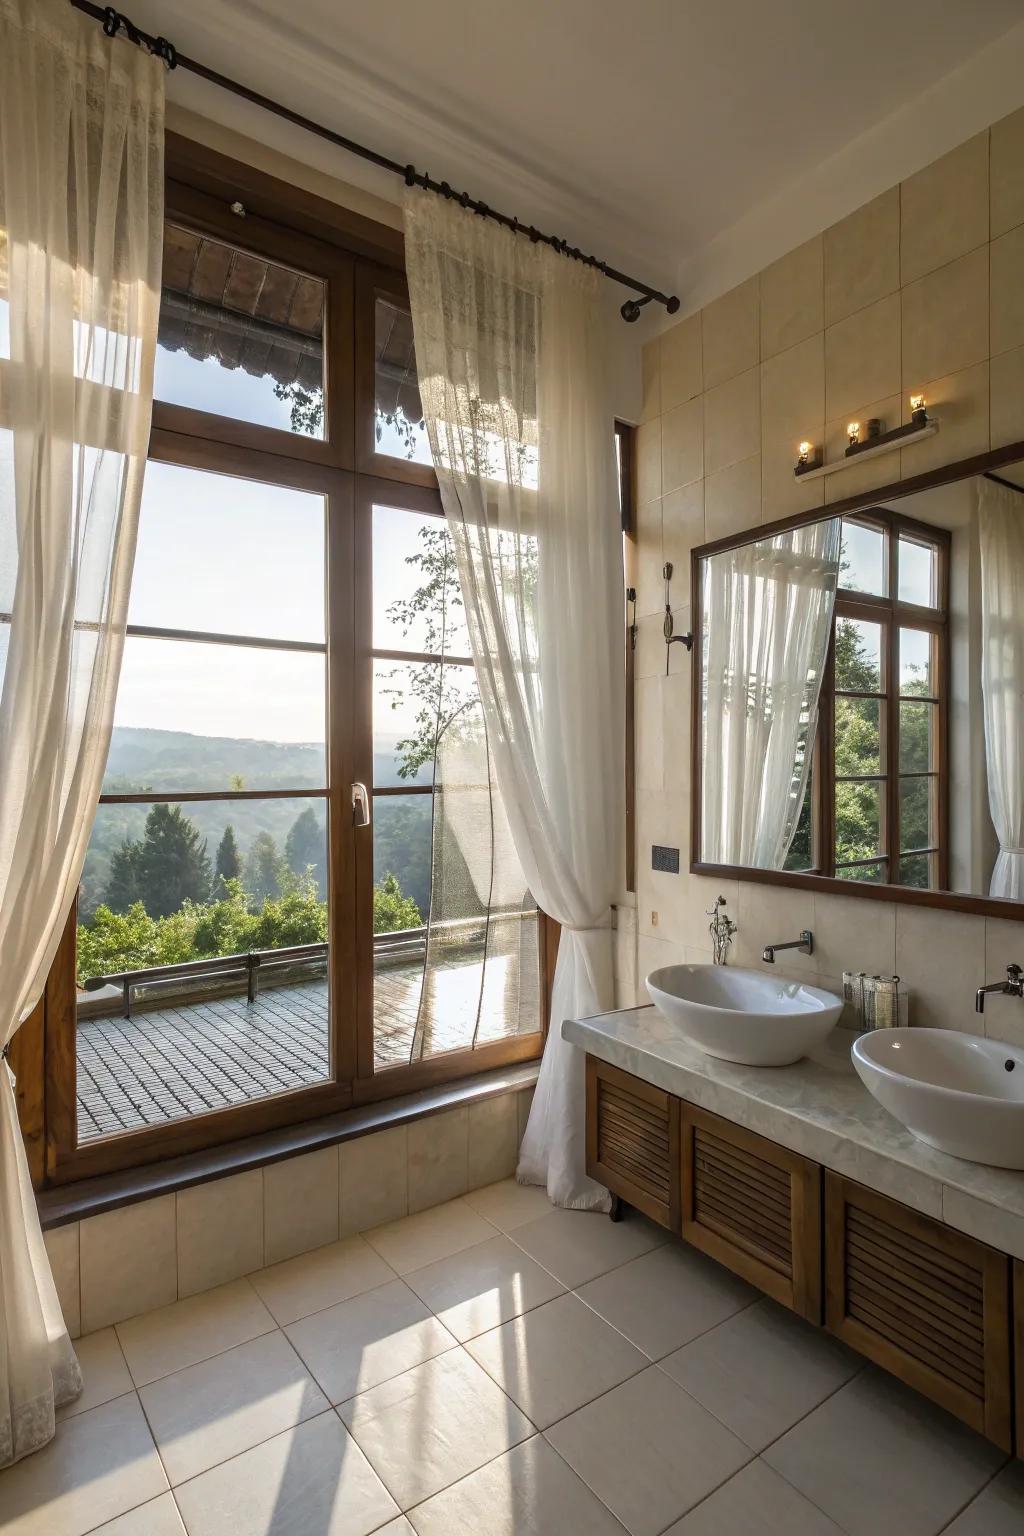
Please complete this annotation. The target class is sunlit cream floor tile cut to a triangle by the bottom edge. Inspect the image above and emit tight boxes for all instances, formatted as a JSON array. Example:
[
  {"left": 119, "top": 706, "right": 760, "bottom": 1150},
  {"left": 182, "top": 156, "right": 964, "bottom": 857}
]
[{"left": 410, "top": 1435, "right": 622, "bottom": 1536}]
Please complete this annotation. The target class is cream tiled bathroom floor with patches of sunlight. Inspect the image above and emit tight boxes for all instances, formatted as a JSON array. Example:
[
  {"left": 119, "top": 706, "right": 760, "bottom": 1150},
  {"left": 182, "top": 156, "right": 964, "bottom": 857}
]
[{"left": 0, "top": 1183, "right": 1024, "bottom": 1536}]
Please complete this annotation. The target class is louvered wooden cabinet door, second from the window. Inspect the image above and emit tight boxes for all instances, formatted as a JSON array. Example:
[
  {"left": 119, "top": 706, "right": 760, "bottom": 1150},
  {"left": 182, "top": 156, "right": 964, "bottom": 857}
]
[{"left": 682, "top": 1103, "right": 821, "bottom": 1322}]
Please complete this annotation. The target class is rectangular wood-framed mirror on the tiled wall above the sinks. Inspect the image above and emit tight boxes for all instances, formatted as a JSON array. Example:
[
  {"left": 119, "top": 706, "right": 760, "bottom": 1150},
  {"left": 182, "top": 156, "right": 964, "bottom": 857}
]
[{"left": 691, "top": 455, "right": 1024, "bottom": 917}]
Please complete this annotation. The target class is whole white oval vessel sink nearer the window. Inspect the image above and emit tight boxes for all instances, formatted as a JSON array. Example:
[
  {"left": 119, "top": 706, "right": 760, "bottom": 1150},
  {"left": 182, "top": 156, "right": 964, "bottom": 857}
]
[{"left": 646, "top": 965, "right": 843, "bottom": 1066}]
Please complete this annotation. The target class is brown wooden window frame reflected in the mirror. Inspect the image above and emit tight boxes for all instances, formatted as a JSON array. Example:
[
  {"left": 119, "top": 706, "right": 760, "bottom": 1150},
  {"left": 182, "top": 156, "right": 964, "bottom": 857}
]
[{"left": 811, "top": 507, "right": 952, "bottom": 891}]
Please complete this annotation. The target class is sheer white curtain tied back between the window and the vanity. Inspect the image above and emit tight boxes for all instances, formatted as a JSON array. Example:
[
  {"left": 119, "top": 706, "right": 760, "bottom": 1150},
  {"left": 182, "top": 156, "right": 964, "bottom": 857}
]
[{"left": 405, "top": 189, "right": 625, "bottom": 1209}]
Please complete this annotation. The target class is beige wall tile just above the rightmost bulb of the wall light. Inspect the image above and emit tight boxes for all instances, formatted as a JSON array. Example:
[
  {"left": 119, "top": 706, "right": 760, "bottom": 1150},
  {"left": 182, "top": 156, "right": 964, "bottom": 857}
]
[{"left": 903, "top": 249, "right": 989, "bottom": 393}]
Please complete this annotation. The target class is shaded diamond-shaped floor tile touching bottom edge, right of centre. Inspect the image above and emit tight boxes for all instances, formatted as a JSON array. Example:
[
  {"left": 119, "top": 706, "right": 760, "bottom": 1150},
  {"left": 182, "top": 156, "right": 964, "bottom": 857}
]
[{"left": 547, "top": 1366, "right": 751, "bottom": 1536}]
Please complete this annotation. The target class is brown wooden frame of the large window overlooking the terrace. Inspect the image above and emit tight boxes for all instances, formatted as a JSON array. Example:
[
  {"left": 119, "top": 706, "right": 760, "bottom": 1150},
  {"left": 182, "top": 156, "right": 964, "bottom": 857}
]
[{"left": 32, "top": 135, "right": 549, "bottom": 1184}]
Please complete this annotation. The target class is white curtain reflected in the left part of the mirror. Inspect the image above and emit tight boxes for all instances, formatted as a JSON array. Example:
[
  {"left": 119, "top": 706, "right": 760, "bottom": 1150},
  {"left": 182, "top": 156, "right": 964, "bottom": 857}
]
[{"left": 700, "top": 518, "right": 841, "bottom": 869}]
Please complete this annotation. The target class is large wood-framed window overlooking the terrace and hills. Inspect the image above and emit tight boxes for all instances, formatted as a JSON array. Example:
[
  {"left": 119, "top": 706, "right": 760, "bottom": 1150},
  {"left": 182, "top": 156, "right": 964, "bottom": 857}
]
[{"left": 37, "top": 146, "right": 550, "bottom": 1177}]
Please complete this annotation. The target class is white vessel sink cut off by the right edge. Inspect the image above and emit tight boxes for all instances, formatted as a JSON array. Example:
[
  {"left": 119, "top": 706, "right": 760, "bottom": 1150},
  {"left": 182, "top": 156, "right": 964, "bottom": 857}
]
[{"left": 854, "top": 1029, "right": 1024, "bottom": 1169}]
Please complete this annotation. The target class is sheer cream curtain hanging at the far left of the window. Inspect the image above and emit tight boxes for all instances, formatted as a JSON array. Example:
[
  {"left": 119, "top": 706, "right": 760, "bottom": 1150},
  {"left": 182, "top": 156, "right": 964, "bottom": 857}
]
[{"left": 0, "top": 0, "right": 164, "bottom": 1467}]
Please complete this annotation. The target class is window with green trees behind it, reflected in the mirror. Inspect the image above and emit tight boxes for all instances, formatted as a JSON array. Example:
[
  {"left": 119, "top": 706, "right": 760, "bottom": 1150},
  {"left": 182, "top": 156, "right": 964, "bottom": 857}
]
[{"left": 786, "top": 507, "right": 949, "bottom": 889}]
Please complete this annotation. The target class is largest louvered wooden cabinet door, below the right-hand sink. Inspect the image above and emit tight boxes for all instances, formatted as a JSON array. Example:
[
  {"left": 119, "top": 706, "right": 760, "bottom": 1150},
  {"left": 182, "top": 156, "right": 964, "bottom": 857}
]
[{"left": 824, "top": 1174, "right": 1013, "bottom": 1450}]
